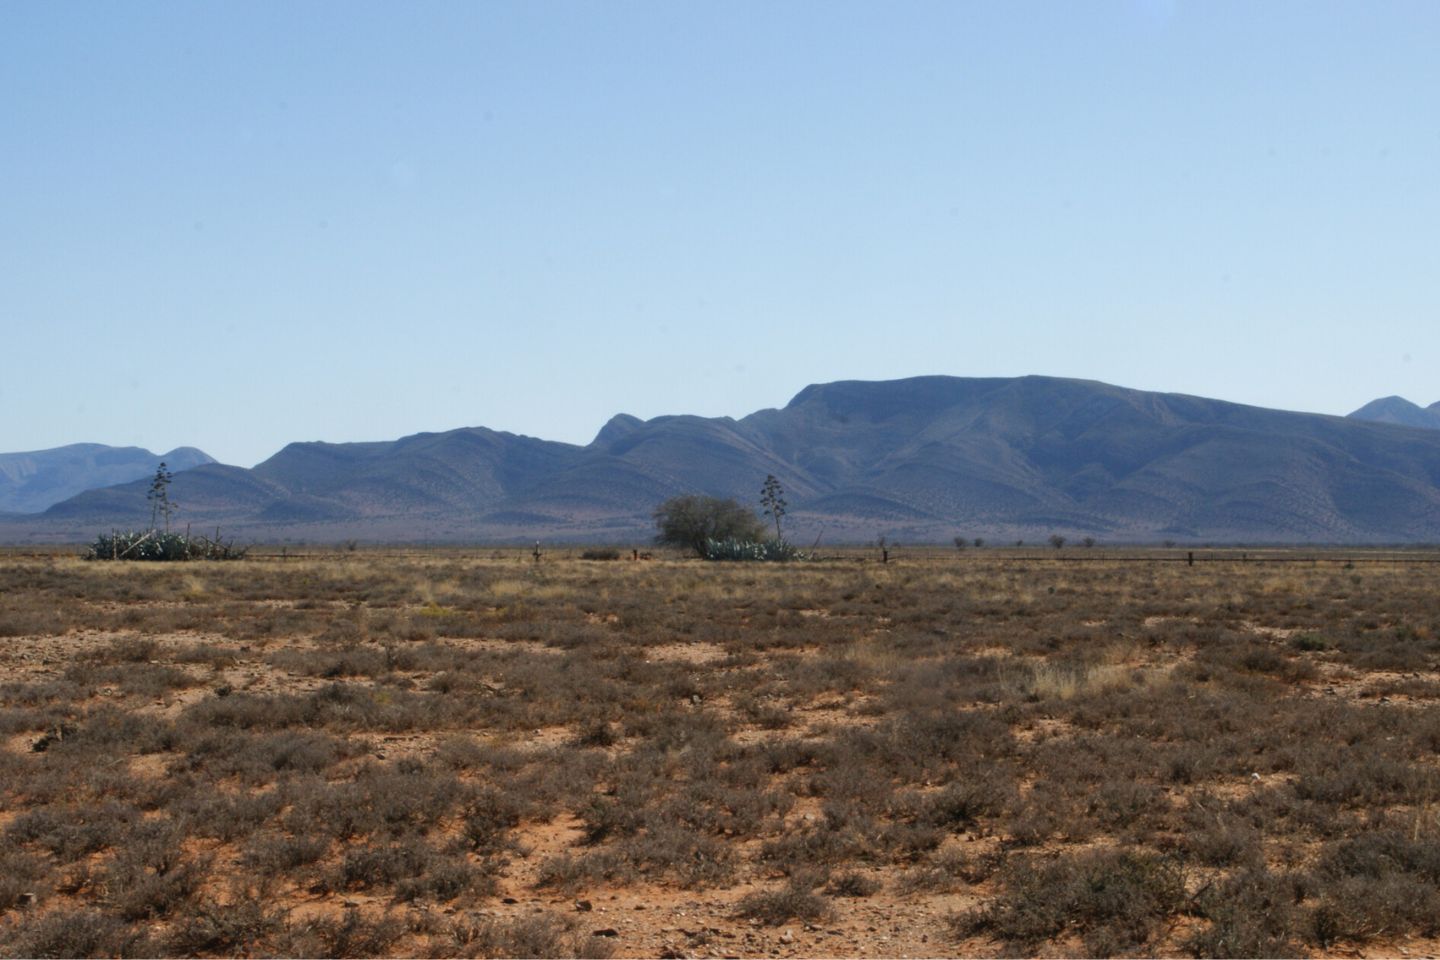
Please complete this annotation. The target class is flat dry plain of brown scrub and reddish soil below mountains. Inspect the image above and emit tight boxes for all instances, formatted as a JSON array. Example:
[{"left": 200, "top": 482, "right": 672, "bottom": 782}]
[{"left": 0, "top": 548, "right": 1440, "bottom": 957}]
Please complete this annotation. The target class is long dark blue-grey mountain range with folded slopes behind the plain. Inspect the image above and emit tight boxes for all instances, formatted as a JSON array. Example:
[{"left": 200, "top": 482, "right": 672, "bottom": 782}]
[{"left": 8, "top": 377, "right": 1440, "bottom": 543}]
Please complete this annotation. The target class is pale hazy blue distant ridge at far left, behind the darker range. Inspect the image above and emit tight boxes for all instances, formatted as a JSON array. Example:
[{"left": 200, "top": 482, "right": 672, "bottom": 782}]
[{"left": 0, "top": 443, "right": 215, "bottom": 514}]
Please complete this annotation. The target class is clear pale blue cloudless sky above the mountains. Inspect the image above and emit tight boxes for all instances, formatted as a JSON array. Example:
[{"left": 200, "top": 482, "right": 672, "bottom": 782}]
[{"left": 0, "top": 0, "right": 1440, "bottom": 466}]
